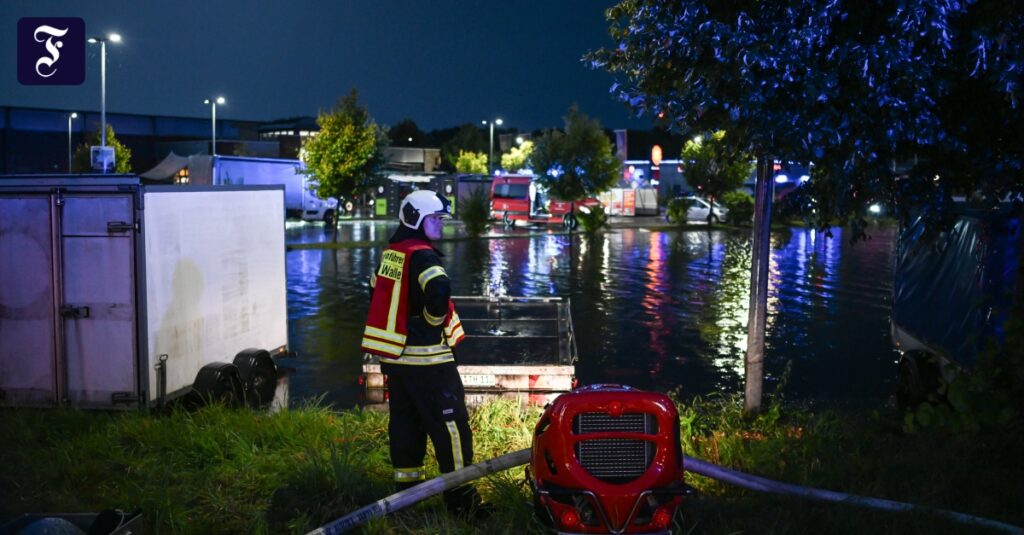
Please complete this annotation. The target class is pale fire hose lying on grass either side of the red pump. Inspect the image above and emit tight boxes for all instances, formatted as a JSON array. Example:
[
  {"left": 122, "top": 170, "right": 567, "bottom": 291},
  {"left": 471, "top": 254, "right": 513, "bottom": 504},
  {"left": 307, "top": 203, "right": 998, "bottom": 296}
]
[{"left": 306, "top": 448, "right": 1024, "bottom": 535}]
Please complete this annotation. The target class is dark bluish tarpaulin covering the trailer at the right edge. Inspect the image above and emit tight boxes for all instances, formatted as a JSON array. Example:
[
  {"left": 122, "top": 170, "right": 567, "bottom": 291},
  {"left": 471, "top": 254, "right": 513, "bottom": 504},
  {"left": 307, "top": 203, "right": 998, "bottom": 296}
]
[{"left": 893, "top": 209, "right": 1024, "bottom": 366}]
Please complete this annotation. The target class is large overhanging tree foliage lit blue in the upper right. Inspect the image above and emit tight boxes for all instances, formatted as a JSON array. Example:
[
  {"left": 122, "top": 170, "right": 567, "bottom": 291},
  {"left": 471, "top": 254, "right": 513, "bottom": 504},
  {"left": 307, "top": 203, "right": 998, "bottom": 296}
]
[{"left": 588, "top": 0, "right": 1024, "bottom": 225}]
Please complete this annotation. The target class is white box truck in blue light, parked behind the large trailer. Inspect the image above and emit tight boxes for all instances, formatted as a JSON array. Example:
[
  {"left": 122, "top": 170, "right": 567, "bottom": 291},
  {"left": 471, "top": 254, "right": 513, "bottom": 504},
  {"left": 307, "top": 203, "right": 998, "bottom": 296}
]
[{"left": 213, "top": 156, "right": 338, "bottom": 224}]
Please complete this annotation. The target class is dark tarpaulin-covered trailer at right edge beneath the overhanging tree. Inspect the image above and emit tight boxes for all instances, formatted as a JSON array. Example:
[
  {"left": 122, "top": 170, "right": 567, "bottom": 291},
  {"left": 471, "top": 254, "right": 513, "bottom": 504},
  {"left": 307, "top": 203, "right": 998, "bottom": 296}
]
[{"left": 891, "top": 202, "right": 1024, "bottom": 407}]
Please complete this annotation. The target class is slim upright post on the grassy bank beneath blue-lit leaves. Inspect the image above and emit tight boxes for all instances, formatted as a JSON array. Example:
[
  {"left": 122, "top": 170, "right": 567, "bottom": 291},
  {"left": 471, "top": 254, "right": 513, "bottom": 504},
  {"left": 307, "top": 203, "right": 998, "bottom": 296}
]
[{"left": 743, "top": 155, "right": 773, "bottom": 415}]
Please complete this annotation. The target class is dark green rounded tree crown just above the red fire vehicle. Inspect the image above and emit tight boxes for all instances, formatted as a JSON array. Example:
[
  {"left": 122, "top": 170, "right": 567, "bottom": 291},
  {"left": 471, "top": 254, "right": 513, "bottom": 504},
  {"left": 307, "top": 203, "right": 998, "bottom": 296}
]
[{"left": 530, "top": 106, "right": 622, "bottom": 201}]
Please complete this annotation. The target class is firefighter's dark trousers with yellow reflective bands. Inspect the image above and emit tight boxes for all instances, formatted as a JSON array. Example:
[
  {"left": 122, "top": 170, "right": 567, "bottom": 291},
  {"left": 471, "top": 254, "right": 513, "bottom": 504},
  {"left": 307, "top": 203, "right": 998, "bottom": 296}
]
[{"left": 381, "top": 363, "right": 475, "bottom": 507}]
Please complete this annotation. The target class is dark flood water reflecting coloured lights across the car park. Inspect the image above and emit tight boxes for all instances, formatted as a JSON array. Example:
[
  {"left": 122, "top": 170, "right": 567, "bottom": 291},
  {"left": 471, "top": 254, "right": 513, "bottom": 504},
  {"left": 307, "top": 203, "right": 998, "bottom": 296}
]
[{"left": 285, "top": 222, "right": 896, "bottom": 408}]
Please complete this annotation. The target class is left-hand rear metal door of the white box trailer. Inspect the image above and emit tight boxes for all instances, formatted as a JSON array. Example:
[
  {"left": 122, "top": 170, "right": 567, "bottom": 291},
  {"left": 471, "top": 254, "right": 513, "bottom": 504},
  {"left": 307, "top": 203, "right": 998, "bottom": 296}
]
[{"left": 0, "top": 194, "right": 59, "bottom": 406}]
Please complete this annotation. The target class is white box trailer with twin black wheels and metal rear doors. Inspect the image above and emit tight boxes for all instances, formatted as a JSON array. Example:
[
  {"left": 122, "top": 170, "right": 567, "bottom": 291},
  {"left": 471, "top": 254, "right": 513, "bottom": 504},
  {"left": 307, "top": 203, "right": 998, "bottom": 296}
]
[{"left": 0, "top": 175, "right": 288, "bottom": 409}]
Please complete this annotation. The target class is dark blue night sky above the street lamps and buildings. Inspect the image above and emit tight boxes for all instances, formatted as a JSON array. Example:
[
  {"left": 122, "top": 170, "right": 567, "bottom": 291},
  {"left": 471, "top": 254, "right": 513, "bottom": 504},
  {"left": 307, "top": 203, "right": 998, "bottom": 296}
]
[{"left": 0, "top": 0, "right": 650, "bottom": 130}]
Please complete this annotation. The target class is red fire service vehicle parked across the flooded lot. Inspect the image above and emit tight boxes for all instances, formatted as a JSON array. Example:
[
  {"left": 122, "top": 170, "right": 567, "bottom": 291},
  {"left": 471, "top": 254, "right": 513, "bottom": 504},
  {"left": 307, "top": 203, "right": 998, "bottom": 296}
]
[{"left": 490, "top": 174, "right": 601, "bottom": 229}]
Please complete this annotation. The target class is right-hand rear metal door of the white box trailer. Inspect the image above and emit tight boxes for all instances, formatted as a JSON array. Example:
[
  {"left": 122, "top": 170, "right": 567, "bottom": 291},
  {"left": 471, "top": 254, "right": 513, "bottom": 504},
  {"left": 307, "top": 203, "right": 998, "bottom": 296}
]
[{"left": 59, "top": 194, "right": 138, "bottom": 407}]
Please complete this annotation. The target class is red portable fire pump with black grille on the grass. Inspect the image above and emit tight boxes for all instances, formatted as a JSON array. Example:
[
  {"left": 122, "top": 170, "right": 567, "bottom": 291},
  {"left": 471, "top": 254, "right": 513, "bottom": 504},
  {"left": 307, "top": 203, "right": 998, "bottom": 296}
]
[{"left": 526, "top": 384, "right": 687, "bottom": 533}]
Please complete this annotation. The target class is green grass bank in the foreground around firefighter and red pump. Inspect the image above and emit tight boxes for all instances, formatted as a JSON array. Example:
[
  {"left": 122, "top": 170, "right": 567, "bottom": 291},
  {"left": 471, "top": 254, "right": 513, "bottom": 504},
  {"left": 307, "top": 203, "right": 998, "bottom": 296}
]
[{"left": 0, "top": 399, "right": 1024, "bottom": 534}]
